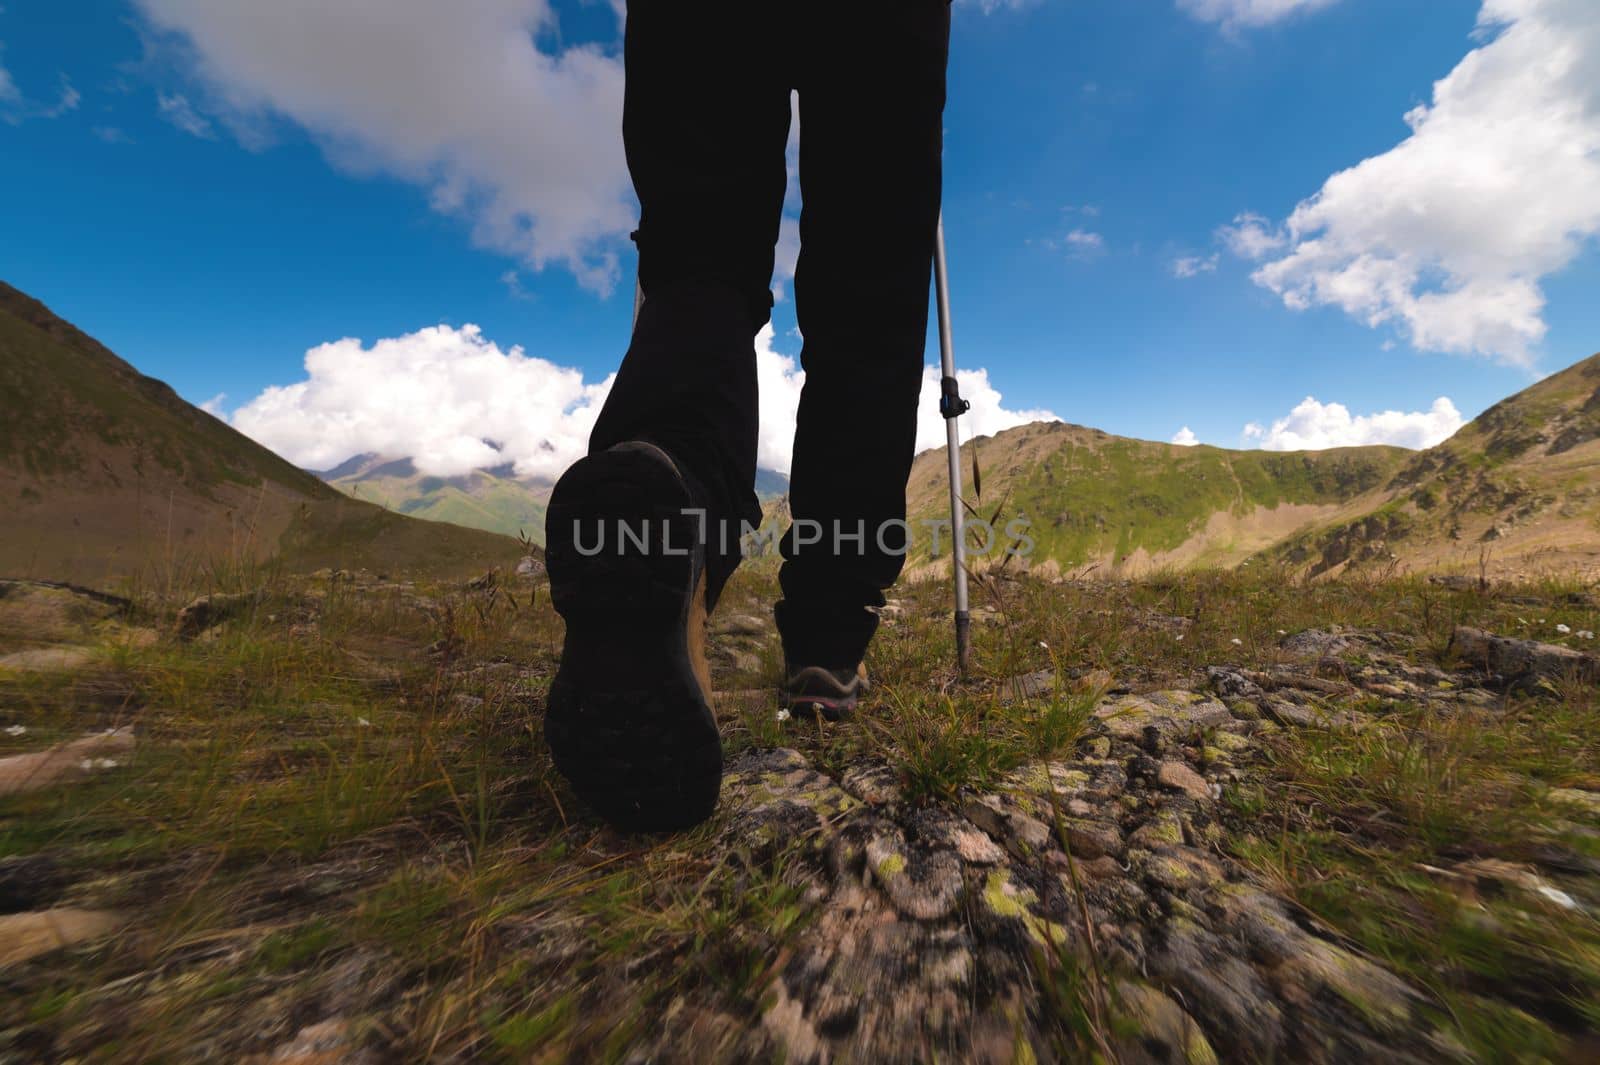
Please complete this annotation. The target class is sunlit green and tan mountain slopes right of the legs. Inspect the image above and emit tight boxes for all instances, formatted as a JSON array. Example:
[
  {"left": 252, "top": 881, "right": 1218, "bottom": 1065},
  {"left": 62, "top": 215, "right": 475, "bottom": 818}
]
[{"left": 909, "top": 355, "right": 1600, "bottom": 576}]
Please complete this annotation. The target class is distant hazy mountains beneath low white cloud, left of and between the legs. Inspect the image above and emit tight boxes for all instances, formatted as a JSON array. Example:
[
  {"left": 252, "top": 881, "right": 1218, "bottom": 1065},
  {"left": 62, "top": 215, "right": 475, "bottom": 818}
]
[{"left": 317, "top": 454, "right": 789, "bottom": 544}]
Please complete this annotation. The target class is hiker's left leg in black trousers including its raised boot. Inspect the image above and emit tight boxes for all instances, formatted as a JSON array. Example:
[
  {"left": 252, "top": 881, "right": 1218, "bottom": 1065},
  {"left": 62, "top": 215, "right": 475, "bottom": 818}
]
[{"left": 544, "top": 0, "right": 789, "bottom": 830}]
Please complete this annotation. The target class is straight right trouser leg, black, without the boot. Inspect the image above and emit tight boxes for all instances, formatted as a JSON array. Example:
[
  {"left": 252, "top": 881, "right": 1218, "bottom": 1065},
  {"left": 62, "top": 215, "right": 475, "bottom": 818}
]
[{"left": 778, "top": 0, "right": 950, "bottom": 672}]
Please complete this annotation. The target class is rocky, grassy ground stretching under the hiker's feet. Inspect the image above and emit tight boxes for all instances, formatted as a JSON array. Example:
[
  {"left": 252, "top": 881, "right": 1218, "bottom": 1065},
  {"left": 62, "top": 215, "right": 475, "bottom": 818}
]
[{"left": 0, "top": 566, "right": 1600, "bottom": 1062}]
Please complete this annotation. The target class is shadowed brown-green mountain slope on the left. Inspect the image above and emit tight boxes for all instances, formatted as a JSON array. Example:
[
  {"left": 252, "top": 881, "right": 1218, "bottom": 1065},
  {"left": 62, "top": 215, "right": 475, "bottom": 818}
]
[{"left": 0, "top": 283, "right": 518, "bottom": 582}]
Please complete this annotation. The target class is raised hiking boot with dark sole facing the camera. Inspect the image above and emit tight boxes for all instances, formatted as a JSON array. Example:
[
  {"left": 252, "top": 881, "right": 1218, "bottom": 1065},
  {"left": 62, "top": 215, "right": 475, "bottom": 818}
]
[{"left": 544, "top": 441, "right": 722, "bottom": 832}]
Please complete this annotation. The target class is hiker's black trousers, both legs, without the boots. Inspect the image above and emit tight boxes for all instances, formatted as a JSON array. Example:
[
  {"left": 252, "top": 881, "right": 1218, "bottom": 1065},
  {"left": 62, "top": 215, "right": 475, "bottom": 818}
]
[{"left": 590, "top": 0, "right": 950, "bottom": 668}]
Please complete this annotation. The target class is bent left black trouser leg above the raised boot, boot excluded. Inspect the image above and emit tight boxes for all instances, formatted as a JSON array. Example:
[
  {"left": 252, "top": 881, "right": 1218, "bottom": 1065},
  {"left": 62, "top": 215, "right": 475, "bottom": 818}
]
[{"left": 590, "top": 0, "right": 789, "bottom": 601}]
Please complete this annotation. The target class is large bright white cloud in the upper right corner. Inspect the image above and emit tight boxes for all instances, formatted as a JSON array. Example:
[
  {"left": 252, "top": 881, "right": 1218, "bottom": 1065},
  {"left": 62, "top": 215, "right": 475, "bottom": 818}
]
[{"left": 1235, "top": 0, "right": 1600, "bottom": 366}]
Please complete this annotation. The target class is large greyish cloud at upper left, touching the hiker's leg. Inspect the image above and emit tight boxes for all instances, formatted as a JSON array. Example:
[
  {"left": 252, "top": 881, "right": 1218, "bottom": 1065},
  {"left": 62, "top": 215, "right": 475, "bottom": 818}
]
[{"left": 136, "top": 0, "right": 635, "bottom": 291}]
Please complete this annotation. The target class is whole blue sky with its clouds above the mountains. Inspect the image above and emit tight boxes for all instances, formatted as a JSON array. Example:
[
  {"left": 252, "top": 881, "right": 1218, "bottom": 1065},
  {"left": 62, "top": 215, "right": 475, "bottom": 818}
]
[{"left": 0, "top": 0, "right": 1600, "bottom": 472}]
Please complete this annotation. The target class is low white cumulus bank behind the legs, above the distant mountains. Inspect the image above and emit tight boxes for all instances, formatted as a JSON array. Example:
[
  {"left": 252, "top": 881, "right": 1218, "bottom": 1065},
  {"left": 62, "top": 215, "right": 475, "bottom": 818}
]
[{"left": 225, "top": 325, "right": 1054, "bottom": 478}]
